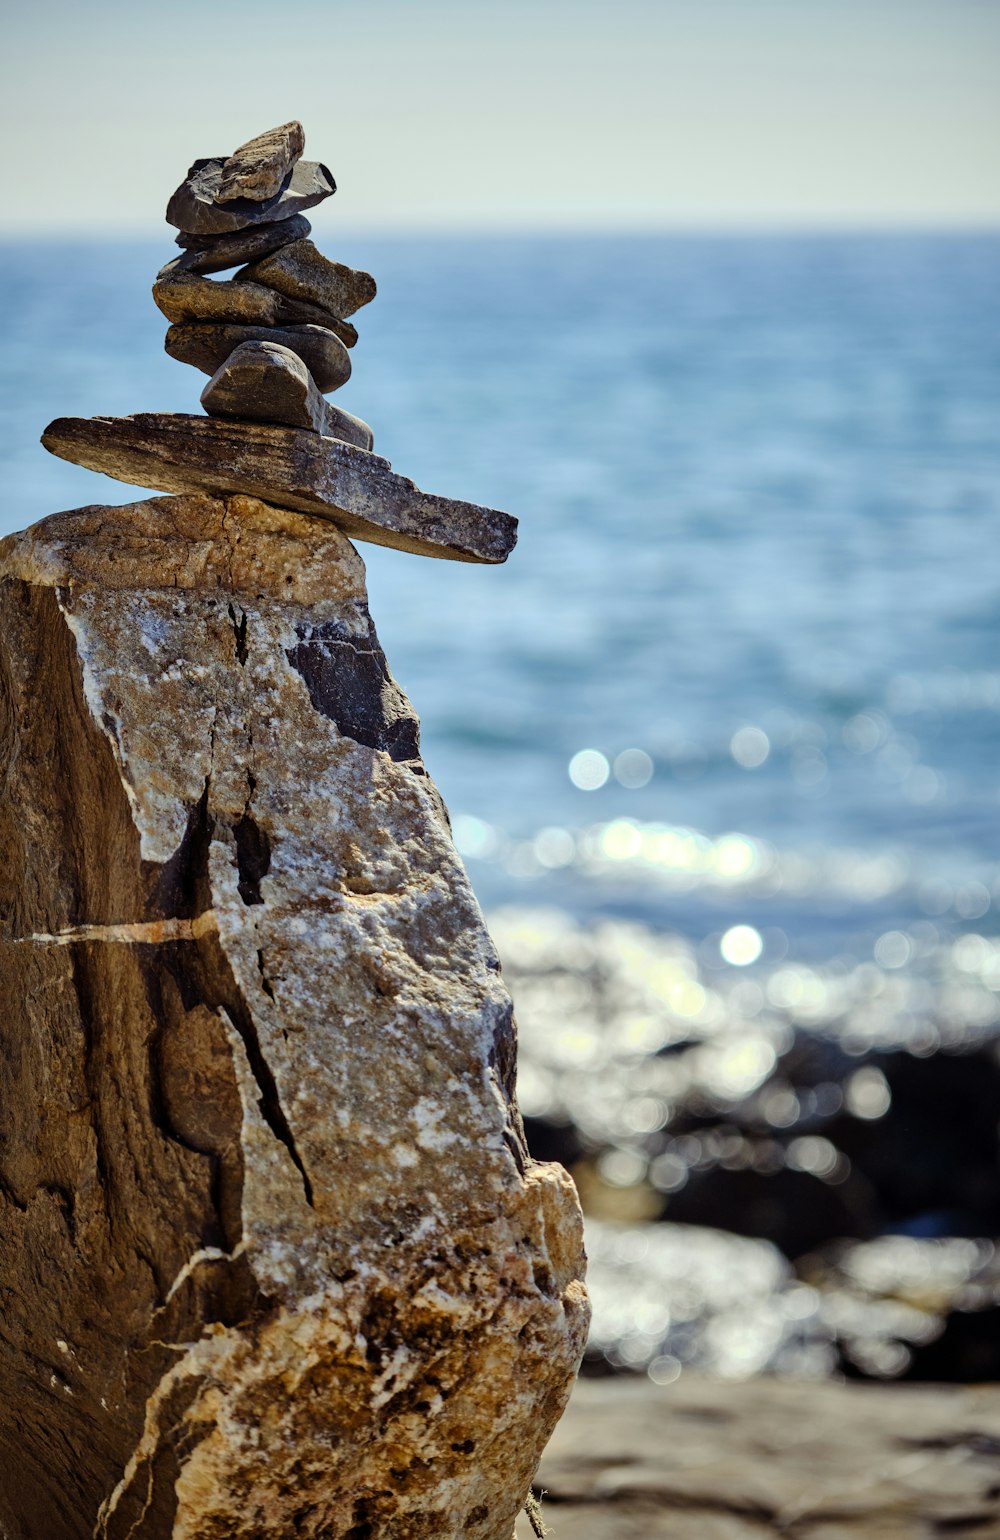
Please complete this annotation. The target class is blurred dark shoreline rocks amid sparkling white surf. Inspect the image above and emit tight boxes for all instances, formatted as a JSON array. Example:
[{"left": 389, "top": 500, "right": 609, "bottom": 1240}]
[{"left": 492, "top": 910, "right": 1000, "bottom": 1381}]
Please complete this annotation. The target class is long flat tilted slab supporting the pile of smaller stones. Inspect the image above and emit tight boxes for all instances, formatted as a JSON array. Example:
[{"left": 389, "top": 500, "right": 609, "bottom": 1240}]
[{"left": 42, "top": 413, "right": 518, "bottom": 562}]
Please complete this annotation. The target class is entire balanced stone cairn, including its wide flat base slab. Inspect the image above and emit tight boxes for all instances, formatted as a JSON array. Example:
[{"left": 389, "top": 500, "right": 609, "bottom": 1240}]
[{"left": 42, "top": 122, "right": 516, "bottom": 562}]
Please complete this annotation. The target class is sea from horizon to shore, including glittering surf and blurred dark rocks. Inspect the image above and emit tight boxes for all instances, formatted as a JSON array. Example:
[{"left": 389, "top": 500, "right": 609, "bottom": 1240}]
[{"left": 0, "top": 240, "right": 1000, "bottom": 1383}]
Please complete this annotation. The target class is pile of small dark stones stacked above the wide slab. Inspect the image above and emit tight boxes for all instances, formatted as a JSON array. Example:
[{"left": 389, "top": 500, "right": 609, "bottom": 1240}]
[{"left": 153, "top": 123, "right": 374, "bottom": 450}]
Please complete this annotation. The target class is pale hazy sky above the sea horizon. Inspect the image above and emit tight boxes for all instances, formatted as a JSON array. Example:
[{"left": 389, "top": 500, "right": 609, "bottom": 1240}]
[{"left": 0, "top": 0, "right": 1000, "bottom": 234}]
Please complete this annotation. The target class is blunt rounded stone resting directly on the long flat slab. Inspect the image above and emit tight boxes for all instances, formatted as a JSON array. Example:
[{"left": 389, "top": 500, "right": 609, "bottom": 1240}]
[{"left": 202, "top": 342, "right": 373, "bottom": 450}]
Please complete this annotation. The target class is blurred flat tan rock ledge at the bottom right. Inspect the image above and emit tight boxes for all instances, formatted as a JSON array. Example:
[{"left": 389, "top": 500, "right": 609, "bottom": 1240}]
[{"left": 518, "top": 1375, "right": 1000, "bottom": 1540}]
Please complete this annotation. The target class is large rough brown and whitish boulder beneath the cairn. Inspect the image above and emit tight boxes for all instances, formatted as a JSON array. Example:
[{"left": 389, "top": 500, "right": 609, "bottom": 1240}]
[{"left": 0, "top": 497, "right": 587, "bottom": 1540}]
